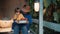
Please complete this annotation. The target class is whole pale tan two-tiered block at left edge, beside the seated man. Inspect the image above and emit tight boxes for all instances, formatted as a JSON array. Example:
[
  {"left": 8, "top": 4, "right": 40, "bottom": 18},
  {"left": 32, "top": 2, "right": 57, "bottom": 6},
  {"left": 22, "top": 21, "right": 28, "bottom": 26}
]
[{"left": 0, "top": 20, "right": 13, "bottom": 32}]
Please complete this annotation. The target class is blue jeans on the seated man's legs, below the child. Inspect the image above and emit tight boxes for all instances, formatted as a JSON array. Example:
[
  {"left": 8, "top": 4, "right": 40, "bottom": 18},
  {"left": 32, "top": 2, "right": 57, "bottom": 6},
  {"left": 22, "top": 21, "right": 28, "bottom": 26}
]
[{"left": 14, "top": 24, "right": 28, "bottom": 34}]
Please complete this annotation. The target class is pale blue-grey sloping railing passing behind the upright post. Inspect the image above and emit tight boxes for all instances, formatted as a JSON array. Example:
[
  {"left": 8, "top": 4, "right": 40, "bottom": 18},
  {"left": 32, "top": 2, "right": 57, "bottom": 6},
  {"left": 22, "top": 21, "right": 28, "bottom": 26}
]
[{"left": 33, "top": 19, "right": 60, "bottom": 32}]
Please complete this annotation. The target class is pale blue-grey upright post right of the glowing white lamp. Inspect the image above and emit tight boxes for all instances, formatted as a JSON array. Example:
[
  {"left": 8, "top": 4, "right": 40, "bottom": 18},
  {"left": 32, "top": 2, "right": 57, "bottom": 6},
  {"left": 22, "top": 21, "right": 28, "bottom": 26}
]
[{"left": 39, "top": 0, "right": 43, "bottom": 34}]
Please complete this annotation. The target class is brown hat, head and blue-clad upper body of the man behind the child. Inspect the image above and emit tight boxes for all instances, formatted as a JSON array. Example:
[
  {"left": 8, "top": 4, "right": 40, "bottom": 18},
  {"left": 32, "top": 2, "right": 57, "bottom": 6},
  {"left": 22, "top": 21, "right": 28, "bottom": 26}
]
[{"left": 21, "top": 5, "right": 32, "bottom": 30}]
